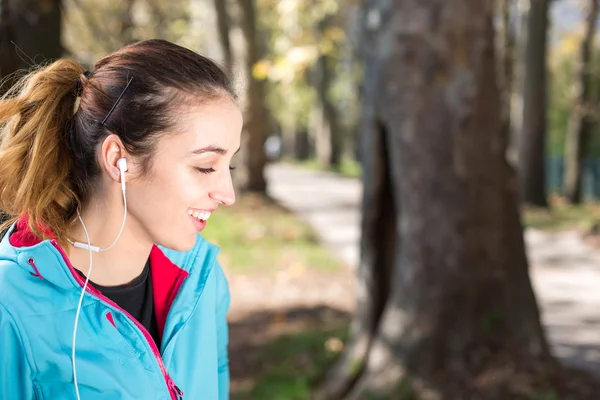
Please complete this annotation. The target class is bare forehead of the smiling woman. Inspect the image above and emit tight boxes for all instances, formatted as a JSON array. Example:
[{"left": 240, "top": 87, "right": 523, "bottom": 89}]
[{"left": 157, "top": 98, "right": 243, "bottom": 154}]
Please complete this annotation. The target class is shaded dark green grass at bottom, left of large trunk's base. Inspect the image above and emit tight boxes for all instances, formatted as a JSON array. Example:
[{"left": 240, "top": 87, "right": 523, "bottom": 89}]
[{"left": 233, "top": 326, "right": 348, "bottom": 400}]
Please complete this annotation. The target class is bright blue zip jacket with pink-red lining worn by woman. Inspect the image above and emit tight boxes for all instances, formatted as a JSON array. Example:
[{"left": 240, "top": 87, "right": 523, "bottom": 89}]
[{"left": 0, "top": 221, "right": 229, "bottom": 400}]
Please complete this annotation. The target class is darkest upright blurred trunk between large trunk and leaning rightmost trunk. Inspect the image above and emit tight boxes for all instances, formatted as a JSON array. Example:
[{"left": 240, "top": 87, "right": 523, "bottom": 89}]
[{"left": 519, "top": 0, "right": 550, "bottom": 207}]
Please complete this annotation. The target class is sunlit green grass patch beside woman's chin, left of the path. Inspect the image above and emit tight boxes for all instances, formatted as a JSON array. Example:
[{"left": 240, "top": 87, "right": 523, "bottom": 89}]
[{"left": 203, "top": 195, "right": 340, "bottom": 273}]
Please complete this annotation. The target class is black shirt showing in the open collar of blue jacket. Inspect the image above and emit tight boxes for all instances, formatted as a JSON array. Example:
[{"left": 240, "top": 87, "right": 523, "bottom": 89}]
[{"left": 79, "top": 261, "right": 160, "bottom": 348}]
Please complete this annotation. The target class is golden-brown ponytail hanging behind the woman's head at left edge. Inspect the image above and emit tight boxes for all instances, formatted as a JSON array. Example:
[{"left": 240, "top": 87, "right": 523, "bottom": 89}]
[{"left": 0, "top": 59, "right": 83, "bottom": 244}]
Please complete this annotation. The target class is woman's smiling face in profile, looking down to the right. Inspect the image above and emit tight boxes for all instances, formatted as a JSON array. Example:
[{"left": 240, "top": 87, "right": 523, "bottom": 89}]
[{"left": 127, "top": 98, "right": 243, "bottom": 251}]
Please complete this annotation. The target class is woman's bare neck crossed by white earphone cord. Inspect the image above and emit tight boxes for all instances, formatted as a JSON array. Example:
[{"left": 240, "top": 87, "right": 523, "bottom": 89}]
[{"left": 67, "top": 193, "right": 152, "bottom": 286}]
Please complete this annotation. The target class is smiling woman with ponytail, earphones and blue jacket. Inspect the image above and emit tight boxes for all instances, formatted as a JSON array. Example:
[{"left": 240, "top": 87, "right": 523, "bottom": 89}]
[{"left": 0, "top": 40, "right": 242, "bottom": 400}]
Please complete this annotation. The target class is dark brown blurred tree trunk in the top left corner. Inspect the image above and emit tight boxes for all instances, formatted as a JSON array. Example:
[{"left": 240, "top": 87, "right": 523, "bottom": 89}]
[{"left": 0, "top": 0, "right": 64, "bottom": 89}]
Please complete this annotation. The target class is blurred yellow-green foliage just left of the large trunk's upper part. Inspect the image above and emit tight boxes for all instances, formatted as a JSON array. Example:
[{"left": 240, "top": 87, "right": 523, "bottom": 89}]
[{"left": 254, "top": 0, "right": 360, "bottom": 138}]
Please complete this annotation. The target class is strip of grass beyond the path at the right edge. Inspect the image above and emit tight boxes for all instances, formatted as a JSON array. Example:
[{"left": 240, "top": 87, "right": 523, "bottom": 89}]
[{"left": 522, "top": 199, "right": 600, "bottom": 232}]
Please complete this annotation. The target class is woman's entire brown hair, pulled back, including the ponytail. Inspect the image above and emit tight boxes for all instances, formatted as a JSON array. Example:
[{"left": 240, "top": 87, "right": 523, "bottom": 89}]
[{"left": 0, "top": 39, "right": 235, "bottom": 244}]
